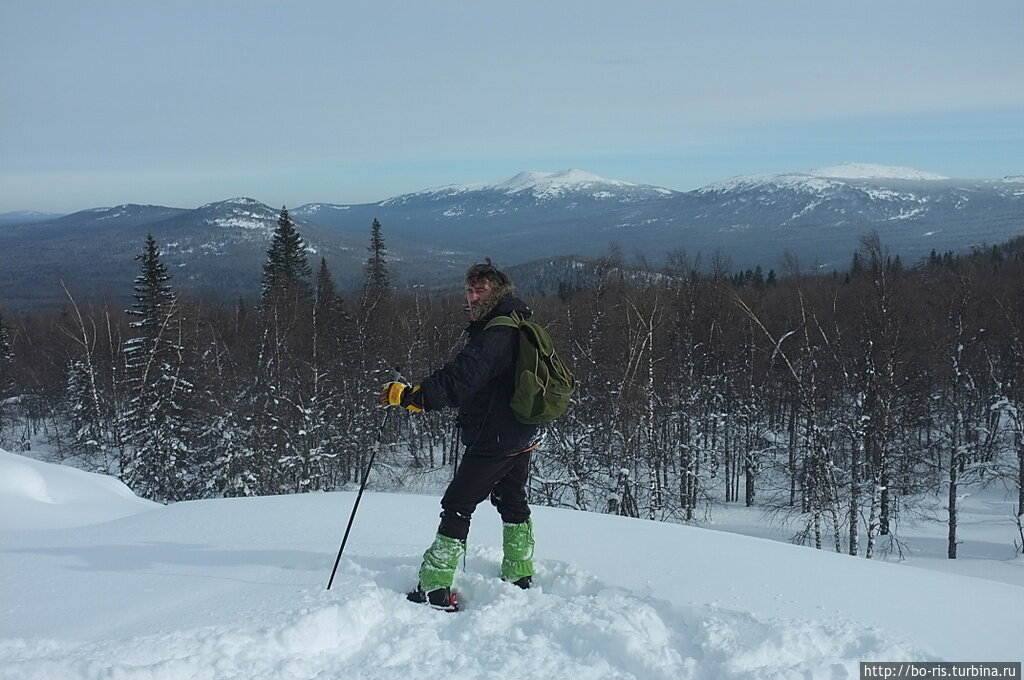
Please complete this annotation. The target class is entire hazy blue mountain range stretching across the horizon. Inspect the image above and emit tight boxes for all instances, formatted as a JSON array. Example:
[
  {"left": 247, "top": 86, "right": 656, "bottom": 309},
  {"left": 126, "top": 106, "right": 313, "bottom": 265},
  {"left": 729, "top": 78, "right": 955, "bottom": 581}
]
[{"left": 0, "top": 164, "right": 1024, "bottom": 307}]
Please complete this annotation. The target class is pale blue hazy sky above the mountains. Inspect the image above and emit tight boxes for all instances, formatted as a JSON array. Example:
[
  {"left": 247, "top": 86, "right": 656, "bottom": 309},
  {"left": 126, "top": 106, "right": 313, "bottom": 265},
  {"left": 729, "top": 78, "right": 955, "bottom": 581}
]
[{"left": 0, "top": 0, "right": 1024, "bottom": 212}]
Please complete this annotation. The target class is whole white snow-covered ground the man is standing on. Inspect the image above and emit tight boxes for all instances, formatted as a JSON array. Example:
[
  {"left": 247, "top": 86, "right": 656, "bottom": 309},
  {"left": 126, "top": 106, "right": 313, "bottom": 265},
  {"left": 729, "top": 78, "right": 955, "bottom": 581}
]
[{"left": 0, "top": 453, "right": 1024, "bottom": 680}]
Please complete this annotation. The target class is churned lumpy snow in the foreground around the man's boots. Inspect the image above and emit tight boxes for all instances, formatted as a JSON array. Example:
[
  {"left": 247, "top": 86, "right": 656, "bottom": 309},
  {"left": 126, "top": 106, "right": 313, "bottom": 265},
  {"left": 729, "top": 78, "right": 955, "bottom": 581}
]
[{"left": 0, "top": 559, "right": 929, "bottom": 680}]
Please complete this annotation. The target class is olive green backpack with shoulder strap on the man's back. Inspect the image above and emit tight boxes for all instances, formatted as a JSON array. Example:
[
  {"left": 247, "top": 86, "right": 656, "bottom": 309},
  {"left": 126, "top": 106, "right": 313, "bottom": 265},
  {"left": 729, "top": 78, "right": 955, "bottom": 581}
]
[{"left": 484, "top": 311, "right": 575, "bottom": 425}]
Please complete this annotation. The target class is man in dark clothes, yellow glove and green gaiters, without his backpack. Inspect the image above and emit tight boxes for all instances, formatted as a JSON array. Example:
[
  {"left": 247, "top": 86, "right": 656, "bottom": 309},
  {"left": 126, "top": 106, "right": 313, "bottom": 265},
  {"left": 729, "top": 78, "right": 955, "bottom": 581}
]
[{"left": 381, "top": 258, "right": 541, "bottom": 609}]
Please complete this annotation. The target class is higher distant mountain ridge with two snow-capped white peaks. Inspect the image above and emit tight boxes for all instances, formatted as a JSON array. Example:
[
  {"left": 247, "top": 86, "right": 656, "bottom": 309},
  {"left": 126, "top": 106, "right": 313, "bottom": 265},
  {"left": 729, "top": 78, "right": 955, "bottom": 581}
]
[{"left": 295, "top": 164, "right": 1024, "bottom": 267}]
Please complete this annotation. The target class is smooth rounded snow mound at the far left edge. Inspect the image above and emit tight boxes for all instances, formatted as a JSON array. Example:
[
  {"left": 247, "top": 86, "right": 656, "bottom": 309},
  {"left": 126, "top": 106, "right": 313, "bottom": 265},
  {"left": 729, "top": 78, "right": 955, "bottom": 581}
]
[{"left": 0, "top": 451, "right": 162, "bottom": 529}]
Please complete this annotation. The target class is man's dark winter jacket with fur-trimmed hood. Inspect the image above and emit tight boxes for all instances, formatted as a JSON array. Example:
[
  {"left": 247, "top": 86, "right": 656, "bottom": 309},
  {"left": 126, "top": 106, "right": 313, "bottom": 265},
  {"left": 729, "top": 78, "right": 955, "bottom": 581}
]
[{"left": 421, "top": 294, "right": 540, "bottom": 456}]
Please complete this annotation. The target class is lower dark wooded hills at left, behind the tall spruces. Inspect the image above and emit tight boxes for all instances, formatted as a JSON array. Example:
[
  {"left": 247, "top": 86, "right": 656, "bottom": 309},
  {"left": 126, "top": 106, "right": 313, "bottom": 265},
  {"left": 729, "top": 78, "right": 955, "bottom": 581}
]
[{"left": 0, "top": 192, "right": 468, "bottom": 309}]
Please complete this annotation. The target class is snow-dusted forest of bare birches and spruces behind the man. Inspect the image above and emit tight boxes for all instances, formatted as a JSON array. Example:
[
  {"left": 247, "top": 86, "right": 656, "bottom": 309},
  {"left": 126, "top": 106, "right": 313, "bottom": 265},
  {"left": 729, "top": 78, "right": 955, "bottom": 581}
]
[{"left": 0, "top": 210, "right": 1024, "bottom": 558}]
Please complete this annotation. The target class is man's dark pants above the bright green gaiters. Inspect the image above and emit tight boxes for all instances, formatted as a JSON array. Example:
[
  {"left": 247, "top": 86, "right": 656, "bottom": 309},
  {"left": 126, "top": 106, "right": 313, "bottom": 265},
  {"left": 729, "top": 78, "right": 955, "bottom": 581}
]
[{"left": 437, "top": 452, "right": 529, "bottom": 541}]
